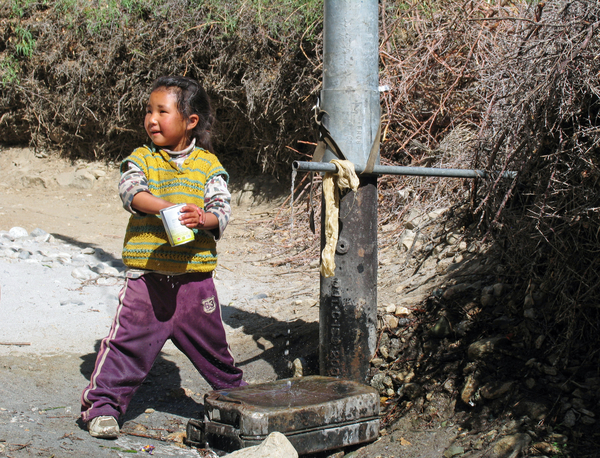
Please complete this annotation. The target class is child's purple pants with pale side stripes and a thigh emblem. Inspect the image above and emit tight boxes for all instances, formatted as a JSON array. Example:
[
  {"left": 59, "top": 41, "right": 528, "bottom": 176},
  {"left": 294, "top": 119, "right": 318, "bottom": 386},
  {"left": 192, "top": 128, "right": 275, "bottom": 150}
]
[{"left": 81, "top": 272, "right": 245, "bottom": 422}]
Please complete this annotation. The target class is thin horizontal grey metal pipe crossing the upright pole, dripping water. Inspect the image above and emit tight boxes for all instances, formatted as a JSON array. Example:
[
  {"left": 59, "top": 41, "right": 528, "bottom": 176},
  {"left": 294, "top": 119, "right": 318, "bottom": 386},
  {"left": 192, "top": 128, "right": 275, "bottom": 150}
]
[{"left": 292, "top": 161, "right": 517, "bottom": 178}]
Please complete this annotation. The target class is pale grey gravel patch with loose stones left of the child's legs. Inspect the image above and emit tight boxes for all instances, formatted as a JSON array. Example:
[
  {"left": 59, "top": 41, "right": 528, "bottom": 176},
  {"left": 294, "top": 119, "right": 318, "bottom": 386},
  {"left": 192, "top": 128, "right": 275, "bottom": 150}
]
[{"left": 0, "top": 227, "right": 125, "bottom": 355}]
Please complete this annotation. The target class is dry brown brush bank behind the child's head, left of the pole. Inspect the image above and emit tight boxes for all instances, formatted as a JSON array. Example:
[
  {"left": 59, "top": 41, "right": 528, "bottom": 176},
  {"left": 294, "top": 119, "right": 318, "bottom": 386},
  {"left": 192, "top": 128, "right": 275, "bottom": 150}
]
[{"left": 0, "top": 0, "right": 320, "bottom": 175}]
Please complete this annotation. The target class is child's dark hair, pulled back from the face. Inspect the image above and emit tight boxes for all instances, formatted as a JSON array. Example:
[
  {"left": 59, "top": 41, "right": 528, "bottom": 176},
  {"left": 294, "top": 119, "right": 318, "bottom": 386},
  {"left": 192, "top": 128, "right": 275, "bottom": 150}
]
[{"left": 152, "top": 76, "right": 215, "bottom": 153}]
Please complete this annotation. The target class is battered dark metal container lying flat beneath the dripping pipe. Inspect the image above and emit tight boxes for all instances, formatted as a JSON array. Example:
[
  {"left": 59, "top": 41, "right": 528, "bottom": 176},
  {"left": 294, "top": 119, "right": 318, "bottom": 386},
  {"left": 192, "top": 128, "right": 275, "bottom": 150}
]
[{"left": 186, "top": 376, "right": 379, "bottom": 455}]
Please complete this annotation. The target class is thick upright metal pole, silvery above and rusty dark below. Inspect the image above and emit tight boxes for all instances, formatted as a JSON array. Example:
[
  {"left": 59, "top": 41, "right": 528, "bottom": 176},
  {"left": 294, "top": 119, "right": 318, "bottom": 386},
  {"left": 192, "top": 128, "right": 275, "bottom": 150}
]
[{"left": 319, "top": 0, "right": 380, "bottom": 383}]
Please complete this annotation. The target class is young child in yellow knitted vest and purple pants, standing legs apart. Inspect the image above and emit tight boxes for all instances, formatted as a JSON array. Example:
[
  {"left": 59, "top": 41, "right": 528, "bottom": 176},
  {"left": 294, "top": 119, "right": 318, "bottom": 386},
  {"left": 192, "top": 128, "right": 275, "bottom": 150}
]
[{"left": 81, "top": 77, "right": 245, "bottom": 438}]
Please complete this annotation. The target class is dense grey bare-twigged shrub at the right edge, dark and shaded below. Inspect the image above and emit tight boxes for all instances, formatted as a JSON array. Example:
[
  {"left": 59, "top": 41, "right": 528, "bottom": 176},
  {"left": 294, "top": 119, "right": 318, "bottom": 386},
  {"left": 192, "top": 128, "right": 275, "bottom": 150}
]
[{"left": 475, "top": 0, "right": 600, "bottom": 356}]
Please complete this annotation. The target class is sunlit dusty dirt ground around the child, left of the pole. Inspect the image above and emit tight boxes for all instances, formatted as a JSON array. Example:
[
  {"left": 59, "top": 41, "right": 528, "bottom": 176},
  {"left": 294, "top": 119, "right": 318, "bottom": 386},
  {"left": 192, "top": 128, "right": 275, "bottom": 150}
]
[{"left": 0, "top": 149, "right": 318, "bottom": 457}]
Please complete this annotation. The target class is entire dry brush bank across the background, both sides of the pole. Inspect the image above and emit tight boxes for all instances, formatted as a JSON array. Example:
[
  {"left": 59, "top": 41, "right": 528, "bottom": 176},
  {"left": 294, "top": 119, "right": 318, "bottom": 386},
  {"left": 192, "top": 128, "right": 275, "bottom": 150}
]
[{"left": 0, "top": 0, "right": 600, "bottom": 364}]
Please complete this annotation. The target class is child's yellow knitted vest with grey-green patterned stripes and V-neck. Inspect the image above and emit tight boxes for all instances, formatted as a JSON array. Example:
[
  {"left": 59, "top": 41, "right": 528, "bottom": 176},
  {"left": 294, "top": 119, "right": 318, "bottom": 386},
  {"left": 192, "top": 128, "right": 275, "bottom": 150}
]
[{"left": 121, "top": 146, "right": 228, "bottom": 272}]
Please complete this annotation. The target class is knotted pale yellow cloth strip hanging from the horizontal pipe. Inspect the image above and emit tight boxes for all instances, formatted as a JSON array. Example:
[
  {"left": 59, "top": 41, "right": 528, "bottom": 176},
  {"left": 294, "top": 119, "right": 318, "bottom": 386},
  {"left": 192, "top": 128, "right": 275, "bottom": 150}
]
[{"left": 321, "top": 159, "right": 360, "bottom": 278}]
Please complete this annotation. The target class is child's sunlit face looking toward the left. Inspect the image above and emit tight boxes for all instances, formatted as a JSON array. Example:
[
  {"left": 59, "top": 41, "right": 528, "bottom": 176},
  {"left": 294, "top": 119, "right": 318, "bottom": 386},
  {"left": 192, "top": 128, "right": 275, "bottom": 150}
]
[{"left": 144, "top": 88, "right": 198, "bottom": 151}]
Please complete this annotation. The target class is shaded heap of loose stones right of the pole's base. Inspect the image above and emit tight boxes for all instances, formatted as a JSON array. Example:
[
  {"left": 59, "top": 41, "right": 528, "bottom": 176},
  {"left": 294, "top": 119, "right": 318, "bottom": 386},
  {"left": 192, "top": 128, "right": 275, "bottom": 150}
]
[{"left": 370, "top": 209, "right": 600, "bottom": 457}]
